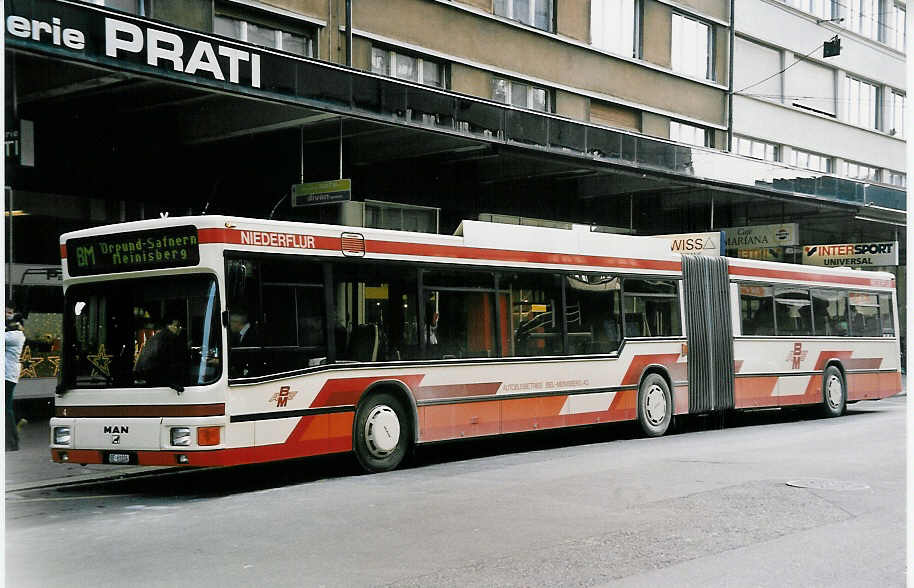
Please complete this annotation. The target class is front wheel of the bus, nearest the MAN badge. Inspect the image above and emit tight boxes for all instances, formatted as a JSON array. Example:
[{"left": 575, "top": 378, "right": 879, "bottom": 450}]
[{"left": 352, "top": 392, "right": 411, "bottom": 473}]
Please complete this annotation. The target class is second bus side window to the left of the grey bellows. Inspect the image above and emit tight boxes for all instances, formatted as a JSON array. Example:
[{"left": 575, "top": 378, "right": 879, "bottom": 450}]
[{"left": 565, "top": 274, "right": 622, "bottom": 355}]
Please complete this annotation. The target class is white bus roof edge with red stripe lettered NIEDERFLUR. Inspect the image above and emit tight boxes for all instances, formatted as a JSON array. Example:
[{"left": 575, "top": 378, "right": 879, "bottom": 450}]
[{"left": 60, "top": 215, "right": 895, "bottom": 287}]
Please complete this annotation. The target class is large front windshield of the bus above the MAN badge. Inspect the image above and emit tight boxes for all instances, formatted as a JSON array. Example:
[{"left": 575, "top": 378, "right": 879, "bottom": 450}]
[{"left": 63, "top": 275, "right": 222, "bottom": 392}]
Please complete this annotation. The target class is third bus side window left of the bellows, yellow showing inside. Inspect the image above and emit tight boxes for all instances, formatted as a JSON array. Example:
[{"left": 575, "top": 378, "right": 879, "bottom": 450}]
[{"left": 499, "top": 273, "right": 572, "bottom": 356}]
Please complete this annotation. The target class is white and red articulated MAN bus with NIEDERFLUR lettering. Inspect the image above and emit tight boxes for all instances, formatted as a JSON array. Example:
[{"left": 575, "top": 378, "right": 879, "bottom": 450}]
[{"left": 50, "top": 216, "right": 901, "bottom": 472}]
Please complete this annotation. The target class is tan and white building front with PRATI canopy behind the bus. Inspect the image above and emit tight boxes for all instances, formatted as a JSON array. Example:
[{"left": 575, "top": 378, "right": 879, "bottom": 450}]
[{"left": 4, "top": 0, "right": 906, "bottom": 402}]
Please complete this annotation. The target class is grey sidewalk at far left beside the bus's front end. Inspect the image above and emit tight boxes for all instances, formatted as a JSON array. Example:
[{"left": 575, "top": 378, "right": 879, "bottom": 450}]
[{"left": 6, "top": 419, "right": 171, "bottom": 492}]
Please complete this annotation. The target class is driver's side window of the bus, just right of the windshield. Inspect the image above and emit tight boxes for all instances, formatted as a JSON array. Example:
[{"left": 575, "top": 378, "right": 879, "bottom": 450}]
[{"left": 226, "top": 258, "right": 327, "bottom": 378}]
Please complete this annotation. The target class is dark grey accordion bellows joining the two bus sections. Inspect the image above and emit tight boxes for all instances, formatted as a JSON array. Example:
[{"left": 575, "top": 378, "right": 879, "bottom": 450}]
[{"left": 682, "top": 255, "right": 733, "bottom": 414}]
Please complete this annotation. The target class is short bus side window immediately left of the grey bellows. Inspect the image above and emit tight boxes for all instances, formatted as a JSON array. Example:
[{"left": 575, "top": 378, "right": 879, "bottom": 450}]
[{"left": 622, "top": 279, "right": 682, "bottom": 339}]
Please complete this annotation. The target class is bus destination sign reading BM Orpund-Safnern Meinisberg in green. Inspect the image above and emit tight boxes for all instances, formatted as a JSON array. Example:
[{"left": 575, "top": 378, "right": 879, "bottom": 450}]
[{"left": 66, "top": 226, "right": 200, "bottom": 276}]
